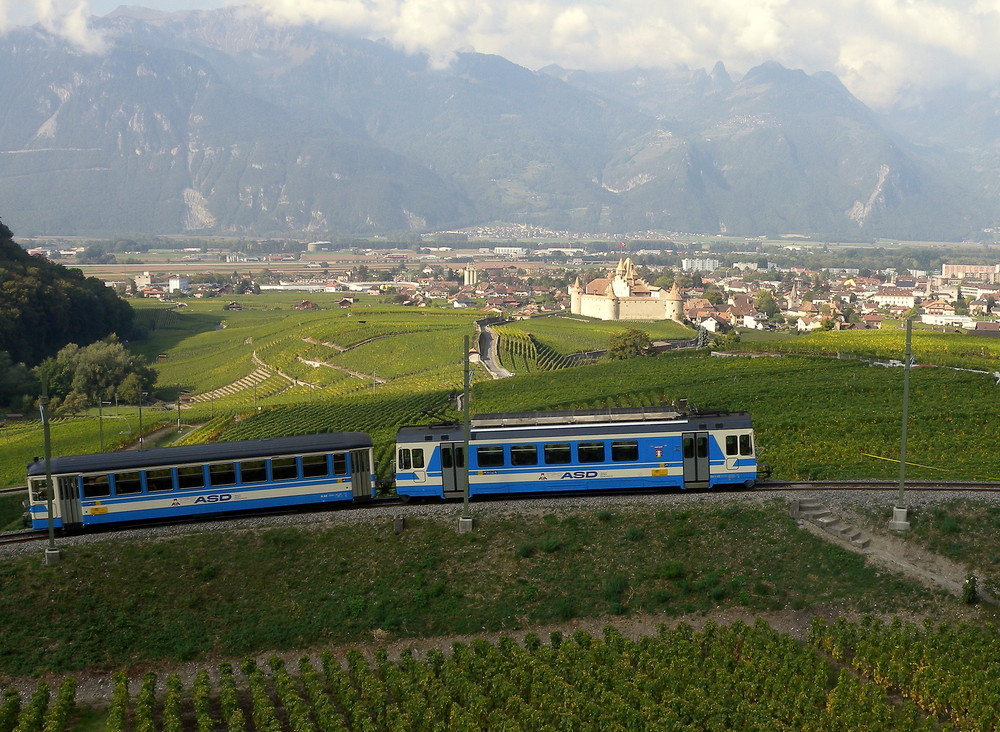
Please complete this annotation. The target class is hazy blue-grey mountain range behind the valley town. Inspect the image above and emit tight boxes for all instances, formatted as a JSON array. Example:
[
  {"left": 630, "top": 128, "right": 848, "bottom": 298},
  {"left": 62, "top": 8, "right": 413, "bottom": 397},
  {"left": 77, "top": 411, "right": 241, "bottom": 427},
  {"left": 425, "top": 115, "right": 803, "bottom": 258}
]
[{"left": 0, "top": 7, "right": 1000, "bottom": 241}]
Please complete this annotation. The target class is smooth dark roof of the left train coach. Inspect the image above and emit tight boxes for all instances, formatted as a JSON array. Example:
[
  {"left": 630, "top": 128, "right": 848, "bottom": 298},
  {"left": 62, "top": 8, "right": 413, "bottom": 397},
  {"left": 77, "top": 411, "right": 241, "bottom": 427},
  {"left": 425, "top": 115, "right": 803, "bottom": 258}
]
[{"left": 28, "top": 432, "right": 372, "bottom": 476}]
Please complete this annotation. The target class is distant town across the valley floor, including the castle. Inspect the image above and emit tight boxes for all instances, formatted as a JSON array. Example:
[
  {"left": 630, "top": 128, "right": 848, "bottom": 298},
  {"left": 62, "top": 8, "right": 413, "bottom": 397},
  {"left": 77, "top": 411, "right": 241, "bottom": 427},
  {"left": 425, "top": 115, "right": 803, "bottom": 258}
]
[{"left": 25, "top": 246, "right": 1000, "bottom": 337}]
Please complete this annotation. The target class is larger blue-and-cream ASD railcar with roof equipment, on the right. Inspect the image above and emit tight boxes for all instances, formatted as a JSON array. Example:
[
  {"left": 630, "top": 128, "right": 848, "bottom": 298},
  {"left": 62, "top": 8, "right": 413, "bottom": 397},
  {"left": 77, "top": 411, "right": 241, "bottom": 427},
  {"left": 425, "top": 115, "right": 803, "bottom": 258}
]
[{"left": 395, "top": 407, "right": 757, "bottom": 498}]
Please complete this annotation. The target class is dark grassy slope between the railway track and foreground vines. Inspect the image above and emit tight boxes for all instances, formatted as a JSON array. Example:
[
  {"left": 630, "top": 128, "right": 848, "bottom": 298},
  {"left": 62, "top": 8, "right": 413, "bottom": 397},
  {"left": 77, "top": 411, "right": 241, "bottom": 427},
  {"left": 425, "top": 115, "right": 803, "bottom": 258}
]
[{"left": 0, "top": 499, "right": 953, "bottom": 674}]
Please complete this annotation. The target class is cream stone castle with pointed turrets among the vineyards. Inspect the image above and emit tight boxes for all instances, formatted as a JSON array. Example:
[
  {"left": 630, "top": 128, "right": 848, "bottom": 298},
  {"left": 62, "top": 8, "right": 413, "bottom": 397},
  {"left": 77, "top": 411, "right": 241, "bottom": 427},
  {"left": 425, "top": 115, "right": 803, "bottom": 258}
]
[{"left": 569, "top": 257, "right": 684, "bottom": 323}]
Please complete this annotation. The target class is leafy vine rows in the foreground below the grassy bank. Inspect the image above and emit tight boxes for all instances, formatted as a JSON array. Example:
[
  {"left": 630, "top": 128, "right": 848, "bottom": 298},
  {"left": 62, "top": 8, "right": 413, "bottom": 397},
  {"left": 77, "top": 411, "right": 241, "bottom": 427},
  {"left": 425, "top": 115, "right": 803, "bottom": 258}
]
[{"left": 9, "top": 618, "right": 1000, "bottom": 732}]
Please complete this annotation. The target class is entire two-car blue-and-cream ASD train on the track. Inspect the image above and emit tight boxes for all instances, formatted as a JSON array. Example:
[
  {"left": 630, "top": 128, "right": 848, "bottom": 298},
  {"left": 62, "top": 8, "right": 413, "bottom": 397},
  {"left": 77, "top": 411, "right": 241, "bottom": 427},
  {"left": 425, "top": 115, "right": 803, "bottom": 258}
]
[{"left": 28, "top": 407, "right": 757, "bottom": 529}]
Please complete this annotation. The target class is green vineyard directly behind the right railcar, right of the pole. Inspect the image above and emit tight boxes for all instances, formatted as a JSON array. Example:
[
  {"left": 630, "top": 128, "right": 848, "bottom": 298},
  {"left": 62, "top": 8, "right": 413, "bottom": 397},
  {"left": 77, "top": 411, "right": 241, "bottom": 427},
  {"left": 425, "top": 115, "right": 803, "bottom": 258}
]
[{"left": 473, "top": 353, "right": 1000, "bottom": 480}]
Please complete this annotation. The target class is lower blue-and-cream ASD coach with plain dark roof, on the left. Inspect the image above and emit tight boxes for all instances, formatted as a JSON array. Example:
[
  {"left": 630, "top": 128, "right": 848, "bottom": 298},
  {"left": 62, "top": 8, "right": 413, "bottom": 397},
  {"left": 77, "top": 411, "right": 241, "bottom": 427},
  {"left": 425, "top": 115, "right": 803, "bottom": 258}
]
[{"left": 28, "top": 432, "right": 374, "bottom": 529}]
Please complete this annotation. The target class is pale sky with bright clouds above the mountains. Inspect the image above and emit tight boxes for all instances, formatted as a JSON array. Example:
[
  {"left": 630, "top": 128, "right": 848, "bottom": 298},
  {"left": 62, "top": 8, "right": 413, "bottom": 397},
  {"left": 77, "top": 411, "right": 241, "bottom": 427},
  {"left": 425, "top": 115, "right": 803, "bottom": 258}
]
[{"left": 0, "top": 0, "right": 1000, "bottom": 108}]
